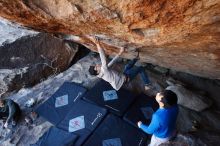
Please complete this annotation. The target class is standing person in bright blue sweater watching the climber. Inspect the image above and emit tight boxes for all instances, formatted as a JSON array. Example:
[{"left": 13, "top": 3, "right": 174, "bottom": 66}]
[{"left": 137, "top": 90, "right": 178, "bottom": 146}]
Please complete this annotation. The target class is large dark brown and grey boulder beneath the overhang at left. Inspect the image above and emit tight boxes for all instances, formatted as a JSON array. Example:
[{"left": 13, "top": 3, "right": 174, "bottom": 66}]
[{"left": 0, "top": 33, "right": 79, "bottom": 94}]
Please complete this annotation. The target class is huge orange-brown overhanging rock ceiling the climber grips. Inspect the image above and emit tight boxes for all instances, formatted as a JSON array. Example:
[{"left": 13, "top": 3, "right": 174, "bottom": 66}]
[{"left": 0, "top": 0, "right": 220, "bottom": 79}]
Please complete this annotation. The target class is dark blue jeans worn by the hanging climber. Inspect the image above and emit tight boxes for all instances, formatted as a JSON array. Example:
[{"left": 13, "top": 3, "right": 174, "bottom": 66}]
[{"left": 123, "top": 59, "right": 150, "bottom": 84}]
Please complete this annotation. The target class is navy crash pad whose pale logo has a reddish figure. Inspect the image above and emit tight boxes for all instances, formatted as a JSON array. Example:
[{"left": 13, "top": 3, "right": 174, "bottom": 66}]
[{"left": 57, "top": 100, "right": 107, "bottom": 146}]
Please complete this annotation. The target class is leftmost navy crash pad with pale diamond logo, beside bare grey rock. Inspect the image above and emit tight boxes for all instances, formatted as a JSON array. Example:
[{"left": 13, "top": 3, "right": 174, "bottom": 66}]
[{"left": 36, "top": 82, "right": 86, "bottom": 125}]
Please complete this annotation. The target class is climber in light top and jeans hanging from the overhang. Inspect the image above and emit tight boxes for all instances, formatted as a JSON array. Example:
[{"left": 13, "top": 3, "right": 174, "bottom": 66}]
[{"left": 89, "top": 37, "right": 150, "bottom": 90}]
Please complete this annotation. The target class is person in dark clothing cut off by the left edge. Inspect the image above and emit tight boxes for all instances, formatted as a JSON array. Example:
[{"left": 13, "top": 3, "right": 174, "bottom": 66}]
[{"left": 0, "top": 99, "right": 21, "bottom": 128}]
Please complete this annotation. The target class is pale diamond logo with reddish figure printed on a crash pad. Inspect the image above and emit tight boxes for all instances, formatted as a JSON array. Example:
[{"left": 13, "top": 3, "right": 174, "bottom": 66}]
[{"left": 69, "top": 116, "right": 85, "bottom": 132}]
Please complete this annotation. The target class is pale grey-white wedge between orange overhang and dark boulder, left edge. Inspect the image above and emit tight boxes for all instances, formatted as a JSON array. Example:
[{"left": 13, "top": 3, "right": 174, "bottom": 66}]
[{"left": 0, "top": 17, "right": 38, "bottom": 46}]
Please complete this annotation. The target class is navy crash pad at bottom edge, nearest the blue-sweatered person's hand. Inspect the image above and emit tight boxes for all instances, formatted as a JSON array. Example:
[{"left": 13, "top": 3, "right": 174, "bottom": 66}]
[{"left": 83, "top": 114, "right": 148, "bottom": 146}]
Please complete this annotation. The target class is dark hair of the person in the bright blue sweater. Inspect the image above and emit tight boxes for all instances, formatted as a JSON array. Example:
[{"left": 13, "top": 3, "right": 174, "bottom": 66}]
[{"left": 160, "top": 90, "right": 178, "bottom": 108}]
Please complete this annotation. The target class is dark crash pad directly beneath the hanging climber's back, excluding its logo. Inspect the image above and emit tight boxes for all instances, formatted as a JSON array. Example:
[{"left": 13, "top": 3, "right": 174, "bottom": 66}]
[{"left": 83, "top": 80, "right": 136, "bottom": 116}]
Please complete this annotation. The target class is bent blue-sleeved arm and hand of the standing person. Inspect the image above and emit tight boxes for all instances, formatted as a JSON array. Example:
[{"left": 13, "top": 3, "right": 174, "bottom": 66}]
[{"left": 138, "top": 115, "right": 160, "bottom": 134}]
